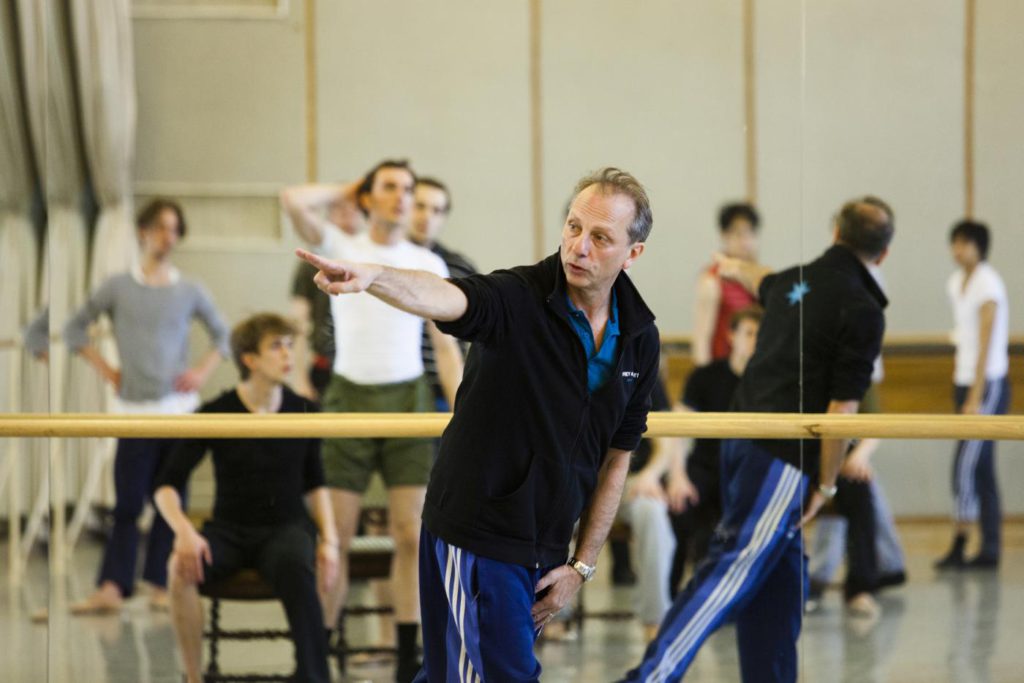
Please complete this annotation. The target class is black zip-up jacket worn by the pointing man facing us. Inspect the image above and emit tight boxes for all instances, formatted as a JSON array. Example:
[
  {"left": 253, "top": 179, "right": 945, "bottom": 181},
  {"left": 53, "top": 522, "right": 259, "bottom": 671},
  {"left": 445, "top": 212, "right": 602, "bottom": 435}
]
[{"left": 423, "top": 253, "right": 659, "bottom": 567}]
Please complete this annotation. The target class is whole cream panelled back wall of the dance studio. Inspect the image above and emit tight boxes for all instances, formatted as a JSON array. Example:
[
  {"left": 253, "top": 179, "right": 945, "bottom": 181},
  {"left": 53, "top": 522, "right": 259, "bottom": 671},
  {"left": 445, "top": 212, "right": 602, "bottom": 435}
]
[{"left": 123, "top": 0, "right": 1024, "bottom": 514}]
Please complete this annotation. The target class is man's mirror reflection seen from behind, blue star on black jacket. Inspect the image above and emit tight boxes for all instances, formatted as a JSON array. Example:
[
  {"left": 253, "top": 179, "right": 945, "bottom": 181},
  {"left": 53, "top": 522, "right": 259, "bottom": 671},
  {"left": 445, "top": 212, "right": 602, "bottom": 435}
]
[{"left": 626, "top": 197, "right": 893, "bottom": 682}]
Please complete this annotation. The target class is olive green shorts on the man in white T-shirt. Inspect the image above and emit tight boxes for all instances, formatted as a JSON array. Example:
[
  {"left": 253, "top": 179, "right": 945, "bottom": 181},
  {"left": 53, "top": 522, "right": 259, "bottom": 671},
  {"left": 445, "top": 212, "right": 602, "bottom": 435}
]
[{"left": 324, "top": 375, "right": 434, "bottom": 494}]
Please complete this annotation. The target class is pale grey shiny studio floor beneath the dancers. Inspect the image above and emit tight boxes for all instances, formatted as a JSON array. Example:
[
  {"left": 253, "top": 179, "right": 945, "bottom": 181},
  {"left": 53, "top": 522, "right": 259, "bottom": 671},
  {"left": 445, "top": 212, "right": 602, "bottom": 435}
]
[{"left": 0, "top": 521, "right": 1024, "bottom": 683}]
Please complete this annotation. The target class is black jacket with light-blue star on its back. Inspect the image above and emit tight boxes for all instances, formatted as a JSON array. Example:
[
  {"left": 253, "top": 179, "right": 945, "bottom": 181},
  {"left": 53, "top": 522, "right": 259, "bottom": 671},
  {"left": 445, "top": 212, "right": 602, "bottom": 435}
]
[{"left": 733, "top": 245, "right": 888, "bottom": 475}]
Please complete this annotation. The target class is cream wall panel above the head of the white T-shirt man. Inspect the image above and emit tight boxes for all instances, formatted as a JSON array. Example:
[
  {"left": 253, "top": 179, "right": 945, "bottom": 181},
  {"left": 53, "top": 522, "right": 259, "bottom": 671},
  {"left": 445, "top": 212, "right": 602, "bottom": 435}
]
[{"left": 315, "top": 0, "right": 532, "bottom": 270}]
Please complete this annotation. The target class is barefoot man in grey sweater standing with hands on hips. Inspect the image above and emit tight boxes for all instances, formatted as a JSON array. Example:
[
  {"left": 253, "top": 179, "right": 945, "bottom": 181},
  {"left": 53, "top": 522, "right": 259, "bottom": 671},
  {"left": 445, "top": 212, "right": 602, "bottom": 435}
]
[{"left": 65, "top": 199, "right": 230, "bottom": 614}]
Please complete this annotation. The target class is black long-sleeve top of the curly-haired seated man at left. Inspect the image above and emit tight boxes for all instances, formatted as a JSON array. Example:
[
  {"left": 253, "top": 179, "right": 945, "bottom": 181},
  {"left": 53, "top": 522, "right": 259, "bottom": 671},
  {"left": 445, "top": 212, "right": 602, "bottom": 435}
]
[{"left": 156, "top": 387, "right": 324, "bottom": 525}]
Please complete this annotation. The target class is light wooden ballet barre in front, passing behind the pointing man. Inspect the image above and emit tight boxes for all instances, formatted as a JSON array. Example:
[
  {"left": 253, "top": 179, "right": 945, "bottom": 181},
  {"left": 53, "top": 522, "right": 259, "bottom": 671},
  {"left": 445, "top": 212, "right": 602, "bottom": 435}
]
[{"left": 0, "top": 413, "right": 1024, "bottom": 440}]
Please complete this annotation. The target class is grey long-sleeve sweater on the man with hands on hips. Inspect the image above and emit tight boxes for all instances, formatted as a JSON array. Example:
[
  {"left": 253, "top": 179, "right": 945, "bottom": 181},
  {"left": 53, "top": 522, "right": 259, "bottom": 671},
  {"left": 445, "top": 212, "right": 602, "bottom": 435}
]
[{"left": 65, "top": 272, "right": 230, "bottom": 401}]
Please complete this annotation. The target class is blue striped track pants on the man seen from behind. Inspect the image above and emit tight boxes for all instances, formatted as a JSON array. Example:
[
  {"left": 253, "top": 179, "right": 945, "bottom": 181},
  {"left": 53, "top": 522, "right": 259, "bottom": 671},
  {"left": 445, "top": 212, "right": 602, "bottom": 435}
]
[{"left": 625, "top": 439, "right": 807, "bottom": 683}]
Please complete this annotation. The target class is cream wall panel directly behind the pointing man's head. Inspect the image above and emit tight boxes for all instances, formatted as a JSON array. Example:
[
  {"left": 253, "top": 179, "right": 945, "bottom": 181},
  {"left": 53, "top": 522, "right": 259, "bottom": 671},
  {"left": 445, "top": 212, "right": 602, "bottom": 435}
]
[{"left": 542, "top": 0, "right": 753, "bottom": 332}]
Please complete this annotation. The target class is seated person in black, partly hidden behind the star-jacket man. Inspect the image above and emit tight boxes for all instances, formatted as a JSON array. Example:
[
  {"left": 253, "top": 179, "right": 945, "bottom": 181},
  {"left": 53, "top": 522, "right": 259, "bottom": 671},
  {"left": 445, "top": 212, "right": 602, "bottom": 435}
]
[{"left": 669, "top": 306, "right": 762, "bottom": 598}]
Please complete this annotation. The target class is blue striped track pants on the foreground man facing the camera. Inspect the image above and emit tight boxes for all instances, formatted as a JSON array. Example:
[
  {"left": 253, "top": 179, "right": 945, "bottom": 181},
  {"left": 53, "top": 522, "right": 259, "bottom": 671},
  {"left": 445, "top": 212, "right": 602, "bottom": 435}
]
[{"left": 415, "top": 526, "right": 552, "bottom": 683}]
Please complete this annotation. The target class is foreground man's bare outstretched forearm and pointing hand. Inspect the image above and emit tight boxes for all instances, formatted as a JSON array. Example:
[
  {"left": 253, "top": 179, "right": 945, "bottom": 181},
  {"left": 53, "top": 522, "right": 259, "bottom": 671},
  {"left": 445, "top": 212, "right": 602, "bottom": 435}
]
[{"left": 295, "top": 249, "right": 469, "bottom": 322}]
